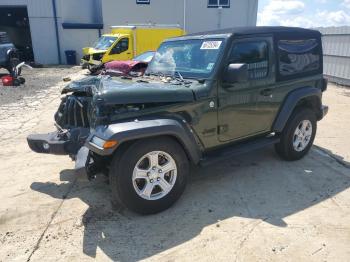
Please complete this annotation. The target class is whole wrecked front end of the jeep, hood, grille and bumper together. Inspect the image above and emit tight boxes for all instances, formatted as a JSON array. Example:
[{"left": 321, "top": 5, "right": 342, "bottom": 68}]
[{"left": 27, "top": 76, "right": 194, "bottom": 179}]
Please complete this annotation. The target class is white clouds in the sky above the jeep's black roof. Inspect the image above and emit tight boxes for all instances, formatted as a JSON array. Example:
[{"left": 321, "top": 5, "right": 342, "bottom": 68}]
[{"left": 258, "top": 0, "right": 350, "bottom": 27}]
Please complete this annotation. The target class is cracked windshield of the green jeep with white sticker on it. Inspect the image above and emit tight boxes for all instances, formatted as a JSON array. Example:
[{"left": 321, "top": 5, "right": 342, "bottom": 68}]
[{"left": 146, "top": 39, "right": 223, "bottom": 78}]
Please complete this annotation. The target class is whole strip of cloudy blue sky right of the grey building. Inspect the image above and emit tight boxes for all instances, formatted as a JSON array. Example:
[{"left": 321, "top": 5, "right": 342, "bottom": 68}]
[{"left": 258, "top": 0, "right": 350, "bottom": 27}]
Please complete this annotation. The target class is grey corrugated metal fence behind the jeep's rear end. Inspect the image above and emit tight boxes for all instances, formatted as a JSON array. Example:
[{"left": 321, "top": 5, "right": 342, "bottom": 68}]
[{"left": 317, "top": 26, "right": 350, "bottom": 86}]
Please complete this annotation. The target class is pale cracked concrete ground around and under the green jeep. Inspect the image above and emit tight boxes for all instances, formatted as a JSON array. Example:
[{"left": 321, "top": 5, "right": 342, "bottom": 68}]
[{"left": 0, "top": 68, "right": 350, "bottom": 261}]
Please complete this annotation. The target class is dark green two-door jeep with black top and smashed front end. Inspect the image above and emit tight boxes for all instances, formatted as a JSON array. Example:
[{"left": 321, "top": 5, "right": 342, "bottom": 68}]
[{"left": 28, "top": 27, "right": 328, "bottom": 214}]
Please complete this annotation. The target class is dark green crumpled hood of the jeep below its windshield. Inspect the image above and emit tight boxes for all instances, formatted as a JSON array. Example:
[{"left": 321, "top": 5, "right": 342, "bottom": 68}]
[{"left": 94, "top": 78, "right": 194, "bottom": 104}]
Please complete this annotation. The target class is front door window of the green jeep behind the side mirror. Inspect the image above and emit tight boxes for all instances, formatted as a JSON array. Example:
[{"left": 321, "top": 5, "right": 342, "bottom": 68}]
[{"left": 230, "top": 41, "right": 269, "bottom": 80}]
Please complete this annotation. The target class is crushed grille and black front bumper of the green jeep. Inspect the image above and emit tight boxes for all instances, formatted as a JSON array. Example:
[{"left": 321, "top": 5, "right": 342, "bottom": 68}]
[{"left": 27, "top": 77, "right": 103, "bottom": 178}]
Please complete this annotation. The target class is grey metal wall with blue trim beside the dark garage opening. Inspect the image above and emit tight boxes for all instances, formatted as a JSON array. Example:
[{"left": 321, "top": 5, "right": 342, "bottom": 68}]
[{"left": 0, "top": 0, "right": 103, "bottom": 64}]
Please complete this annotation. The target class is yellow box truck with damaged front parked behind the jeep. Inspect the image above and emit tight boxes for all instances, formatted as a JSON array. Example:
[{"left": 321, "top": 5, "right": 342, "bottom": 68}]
[{"left": 81, "top": 25, "right": 185, "bottom": 69}]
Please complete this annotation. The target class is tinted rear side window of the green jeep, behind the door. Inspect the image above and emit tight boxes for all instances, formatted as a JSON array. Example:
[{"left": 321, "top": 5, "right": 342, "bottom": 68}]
[{"left": 278, "top": 39, "right": 322, "bottom": 79}]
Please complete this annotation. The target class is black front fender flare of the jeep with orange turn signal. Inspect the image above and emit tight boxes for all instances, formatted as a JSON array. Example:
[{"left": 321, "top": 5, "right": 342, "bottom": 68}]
[{"left": 86, "top": 118, "right": 202, "bottom": 164}]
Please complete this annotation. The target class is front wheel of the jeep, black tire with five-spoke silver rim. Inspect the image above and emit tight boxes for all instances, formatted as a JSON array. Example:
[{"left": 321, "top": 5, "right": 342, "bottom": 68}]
[{"left": 109, "top": 137, "right": 189, "bottom": 214}]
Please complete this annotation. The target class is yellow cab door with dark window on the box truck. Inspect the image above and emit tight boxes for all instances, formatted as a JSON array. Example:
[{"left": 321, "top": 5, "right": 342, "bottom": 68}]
[{"left": 102, "top": 37, "right": 133, "bottom": 63}]
